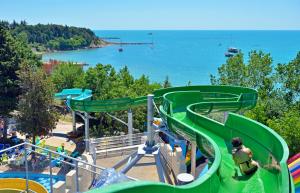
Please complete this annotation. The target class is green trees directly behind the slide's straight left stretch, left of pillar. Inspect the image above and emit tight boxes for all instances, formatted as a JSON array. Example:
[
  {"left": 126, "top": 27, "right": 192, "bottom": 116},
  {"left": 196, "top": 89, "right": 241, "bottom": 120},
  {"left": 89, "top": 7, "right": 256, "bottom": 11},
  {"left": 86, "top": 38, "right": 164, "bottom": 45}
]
[{"left": 84, "top": 64, "right": 160, "bottom": 137}]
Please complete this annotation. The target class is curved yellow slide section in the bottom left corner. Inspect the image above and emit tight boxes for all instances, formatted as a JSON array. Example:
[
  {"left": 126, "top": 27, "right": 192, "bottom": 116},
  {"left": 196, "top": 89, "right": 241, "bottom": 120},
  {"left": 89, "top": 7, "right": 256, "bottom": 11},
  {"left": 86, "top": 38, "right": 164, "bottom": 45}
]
[{"left": 0, "top": 178, "right": 48, "bottom": 193}]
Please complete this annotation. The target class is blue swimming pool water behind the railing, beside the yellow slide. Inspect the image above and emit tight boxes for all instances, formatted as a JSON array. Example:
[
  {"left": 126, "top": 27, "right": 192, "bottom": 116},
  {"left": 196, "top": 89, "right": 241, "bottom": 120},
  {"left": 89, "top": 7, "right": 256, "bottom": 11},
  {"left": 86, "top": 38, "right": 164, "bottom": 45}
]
[{"left": 0, "top": 172, "right": 65, "bottom": 192}]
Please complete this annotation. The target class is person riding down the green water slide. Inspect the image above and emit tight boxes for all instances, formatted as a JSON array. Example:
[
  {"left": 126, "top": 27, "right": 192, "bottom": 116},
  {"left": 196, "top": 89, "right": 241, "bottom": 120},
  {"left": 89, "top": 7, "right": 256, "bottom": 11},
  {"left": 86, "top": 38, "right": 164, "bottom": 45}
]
[{"left": 231, "top": 137, "right": 258, "bottom": 175}]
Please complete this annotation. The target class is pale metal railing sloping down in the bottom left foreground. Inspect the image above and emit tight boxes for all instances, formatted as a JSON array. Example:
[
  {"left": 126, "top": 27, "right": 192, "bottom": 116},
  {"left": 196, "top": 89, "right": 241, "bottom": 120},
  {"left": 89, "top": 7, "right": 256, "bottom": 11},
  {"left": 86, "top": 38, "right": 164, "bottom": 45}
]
[{"left": 0, "top": 142, "right": 136, "bottom": 193}]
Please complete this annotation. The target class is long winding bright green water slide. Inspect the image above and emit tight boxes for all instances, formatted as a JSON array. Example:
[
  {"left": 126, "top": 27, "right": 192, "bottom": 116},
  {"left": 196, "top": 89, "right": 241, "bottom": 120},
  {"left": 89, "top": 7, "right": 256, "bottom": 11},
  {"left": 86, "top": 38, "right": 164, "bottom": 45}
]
[{"left": 75, "top": 86, "right": 294, "bottom": 193}]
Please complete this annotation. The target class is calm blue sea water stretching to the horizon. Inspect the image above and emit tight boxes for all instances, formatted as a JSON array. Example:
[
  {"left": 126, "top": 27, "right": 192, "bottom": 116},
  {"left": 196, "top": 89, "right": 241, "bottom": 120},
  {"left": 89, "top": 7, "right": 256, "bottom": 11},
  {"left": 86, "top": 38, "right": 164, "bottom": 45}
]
[{"left": 43, "top": 30, "right": 300, "bottom": 86}]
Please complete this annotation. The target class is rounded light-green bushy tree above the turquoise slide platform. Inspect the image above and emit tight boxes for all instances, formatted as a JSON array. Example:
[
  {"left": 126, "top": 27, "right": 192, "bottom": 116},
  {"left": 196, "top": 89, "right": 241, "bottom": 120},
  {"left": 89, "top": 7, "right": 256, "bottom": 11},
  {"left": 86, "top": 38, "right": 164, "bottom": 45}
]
[{"left": 51, "top": 62, "right": 84, "bottom": 91}]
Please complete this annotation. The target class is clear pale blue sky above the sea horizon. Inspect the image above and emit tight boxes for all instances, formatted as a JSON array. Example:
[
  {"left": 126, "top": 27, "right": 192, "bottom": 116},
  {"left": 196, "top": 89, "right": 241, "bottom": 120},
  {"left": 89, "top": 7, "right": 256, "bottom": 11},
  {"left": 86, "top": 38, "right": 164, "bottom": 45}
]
[{"left": 0, "top": 0, "right": 300, "bottom": 30}]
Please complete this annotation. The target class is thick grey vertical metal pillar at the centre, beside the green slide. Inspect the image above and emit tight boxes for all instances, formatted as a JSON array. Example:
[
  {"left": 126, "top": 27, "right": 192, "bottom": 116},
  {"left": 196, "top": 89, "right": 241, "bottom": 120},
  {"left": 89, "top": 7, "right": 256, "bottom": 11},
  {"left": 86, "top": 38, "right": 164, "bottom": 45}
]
[{"left": 146, "top": 94, "right": 155, "bottom": 147}]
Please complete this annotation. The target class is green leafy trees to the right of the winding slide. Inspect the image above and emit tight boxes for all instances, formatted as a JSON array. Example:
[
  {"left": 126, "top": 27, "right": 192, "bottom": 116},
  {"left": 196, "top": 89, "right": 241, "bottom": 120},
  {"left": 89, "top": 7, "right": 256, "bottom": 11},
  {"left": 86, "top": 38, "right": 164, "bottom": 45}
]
[{"left": 211, "top": 51, "right": 300, "bottom": 157}]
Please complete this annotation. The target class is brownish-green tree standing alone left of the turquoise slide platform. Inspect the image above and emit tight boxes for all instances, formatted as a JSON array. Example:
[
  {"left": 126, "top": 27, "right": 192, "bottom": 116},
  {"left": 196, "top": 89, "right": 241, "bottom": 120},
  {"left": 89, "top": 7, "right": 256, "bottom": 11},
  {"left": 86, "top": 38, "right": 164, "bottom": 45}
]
[{"left": 17, "top": 63, "right": 58, "bottom": 144}]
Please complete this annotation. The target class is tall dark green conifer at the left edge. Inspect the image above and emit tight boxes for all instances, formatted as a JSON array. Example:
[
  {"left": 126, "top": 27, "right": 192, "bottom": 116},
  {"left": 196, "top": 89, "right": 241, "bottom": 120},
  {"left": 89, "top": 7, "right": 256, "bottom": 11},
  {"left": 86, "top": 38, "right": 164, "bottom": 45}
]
[{"left": 0, "top": 22, "right": 41, "bottom": 138}]
